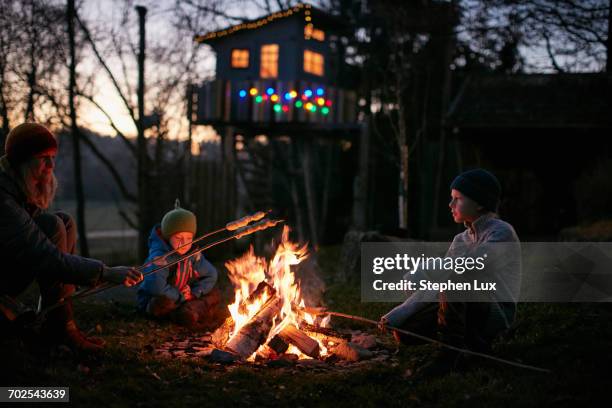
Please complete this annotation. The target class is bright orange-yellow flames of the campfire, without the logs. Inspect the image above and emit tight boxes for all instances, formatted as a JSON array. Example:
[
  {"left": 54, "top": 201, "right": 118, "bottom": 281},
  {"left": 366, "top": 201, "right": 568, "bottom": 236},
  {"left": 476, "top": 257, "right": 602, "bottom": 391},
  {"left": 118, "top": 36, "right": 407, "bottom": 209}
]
[{"left": 225, "top": 226, "right": 329, "bottom": 360}]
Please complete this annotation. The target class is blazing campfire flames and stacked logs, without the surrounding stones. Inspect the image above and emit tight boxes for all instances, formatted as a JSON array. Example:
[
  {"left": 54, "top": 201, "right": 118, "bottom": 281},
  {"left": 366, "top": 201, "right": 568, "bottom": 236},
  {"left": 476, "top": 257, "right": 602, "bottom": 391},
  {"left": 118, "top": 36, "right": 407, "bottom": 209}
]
[{"left": 212, "top": 227, "right": 335, "bottom": 361}]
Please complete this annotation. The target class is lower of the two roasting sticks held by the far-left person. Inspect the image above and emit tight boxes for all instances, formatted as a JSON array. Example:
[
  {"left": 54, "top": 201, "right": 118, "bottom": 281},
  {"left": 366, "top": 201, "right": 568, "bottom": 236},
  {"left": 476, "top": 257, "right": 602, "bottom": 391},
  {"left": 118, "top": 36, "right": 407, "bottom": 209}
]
[{"left": 41, "top": 217, "right": 285, "bottom": 315}]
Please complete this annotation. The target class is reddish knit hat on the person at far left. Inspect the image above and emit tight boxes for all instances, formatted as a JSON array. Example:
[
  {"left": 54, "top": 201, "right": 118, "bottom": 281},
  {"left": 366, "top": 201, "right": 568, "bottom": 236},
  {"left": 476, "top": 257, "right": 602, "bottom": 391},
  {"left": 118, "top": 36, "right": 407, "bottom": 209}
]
[{"left": 4, "top": 123, "right": 57, "bottom": 166}]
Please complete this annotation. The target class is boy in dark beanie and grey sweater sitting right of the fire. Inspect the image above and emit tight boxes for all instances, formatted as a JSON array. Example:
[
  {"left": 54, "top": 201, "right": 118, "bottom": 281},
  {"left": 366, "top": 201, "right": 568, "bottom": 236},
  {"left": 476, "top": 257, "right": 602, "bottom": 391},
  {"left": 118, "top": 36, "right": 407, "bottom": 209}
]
[{"left": 381, "top": 169, "right": 521, "bottom": 375}]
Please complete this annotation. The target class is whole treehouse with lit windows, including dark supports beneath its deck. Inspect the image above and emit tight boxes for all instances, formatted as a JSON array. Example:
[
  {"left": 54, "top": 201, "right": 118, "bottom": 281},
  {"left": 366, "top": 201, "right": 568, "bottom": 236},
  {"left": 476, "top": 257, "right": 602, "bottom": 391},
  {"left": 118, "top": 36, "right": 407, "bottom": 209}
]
[{"left": 188, "top": 4, "right": 365, "bottom": 245}]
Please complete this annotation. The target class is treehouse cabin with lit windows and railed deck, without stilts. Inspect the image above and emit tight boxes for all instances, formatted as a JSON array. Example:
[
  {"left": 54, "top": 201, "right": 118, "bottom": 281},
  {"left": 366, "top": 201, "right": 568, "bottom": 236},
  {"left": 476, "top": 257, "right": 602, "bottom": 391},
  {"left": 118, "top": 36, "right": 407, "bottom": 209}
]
[{"left": 189, "top": 4, "right": 357, "bottom": 132}]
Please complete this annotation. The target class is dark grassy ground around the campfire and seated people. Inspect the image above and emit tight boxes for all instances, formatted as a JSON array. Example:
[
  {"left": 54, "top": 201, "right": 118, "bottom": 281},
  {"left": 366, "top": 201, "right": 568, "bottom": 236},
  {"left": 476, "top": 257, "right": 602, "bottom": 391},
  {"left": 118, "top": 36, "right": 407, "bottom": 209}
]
[{"left": 0, "top": 244, "right": 612, "bottom": 407}]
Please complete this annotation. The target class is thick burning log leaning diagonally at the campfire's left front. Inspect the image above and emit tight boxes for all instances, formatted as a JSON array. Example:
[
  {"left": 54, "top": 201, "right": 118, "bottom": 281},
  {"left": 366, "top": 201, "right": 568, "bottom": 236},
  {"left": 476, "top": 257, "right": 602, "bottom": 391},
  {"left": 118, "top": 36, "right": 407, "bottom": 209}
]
[{"left": 226, "top": 297, "right": 282, "bottom": 358}]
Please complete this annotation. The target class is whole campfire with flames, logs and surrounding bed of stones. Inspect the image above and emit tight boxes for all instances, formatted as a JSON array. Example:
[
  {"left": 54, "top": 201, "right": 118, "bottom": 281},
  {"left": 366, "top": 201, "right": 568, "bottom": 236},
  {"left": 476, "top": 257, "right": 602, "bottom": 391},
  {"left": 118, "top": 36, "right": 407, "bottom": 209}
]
[{"left": 153, "top": 227, "right": 390, "bottom": 366}]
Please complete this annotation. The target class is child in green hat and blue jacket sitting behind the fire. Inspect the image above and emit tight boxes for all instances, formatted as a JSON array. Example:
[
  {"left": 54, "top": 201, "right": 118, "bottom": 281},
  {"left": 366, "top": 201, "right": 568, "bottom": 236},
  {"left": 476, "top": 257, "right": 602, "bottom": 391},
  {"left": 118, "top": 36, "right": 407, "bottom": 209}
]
[{"left": 138, "top": 199, "right": 220, "bottom": 329}]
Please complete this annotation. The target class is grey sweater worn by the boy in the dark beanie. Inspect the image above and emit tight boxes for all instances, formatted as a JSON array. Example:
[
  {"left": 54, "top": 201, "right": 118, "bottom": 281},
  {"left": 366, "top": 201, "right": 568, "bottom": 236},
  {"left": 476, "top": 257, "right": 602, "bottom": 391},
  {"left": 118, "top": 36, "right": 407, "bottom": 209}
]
[{"left": 383, "top": 213, "right": 521, "bottom": 328}]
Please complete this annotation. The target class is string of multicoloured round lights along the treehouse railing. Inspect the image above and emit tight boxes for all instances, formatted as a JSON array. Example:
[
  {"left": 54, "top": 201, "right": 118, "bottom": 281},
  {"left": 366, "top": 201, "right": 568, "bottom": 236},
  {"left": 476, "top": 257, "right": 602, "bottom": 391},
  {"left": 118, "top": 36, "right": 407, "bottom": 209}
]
[{"left": 238, "top": 87, "right": 332, "bottom": 115}]
